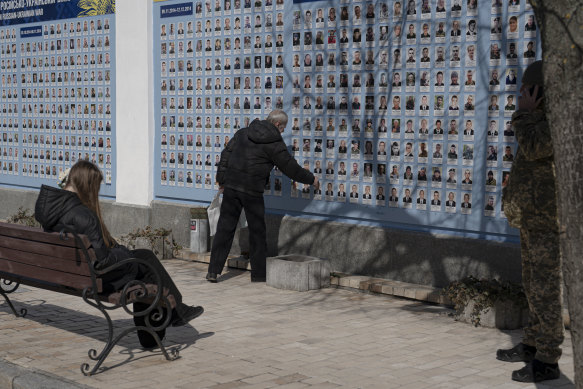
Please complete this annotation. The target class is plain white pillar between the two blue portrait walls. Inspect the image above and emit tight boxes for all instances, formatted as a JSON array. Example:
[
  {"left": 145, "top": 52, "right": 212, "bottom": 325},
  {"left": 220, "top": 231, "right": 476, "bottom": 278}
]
[{"left": 115, "top": 0, "right": 154, "bottom": 205}]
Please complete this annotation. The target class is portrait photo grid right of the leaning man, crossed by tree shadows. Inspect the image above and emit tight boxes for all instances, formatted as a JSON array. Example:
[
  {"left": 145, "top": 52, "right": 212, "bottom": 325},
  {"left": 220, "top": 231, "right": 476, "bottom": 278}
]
[{"left": 290, "top": 0, "right": 536, "bottom": 216}]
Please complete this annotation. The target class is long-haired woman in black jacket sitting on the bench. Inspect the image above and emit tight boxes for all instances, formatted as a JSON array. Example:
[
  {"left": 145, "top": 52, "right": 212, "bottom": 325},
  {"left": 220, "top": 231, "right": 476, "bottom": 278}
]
[{"left": 35, "top": 160, "right": 203, "bottom": 348}]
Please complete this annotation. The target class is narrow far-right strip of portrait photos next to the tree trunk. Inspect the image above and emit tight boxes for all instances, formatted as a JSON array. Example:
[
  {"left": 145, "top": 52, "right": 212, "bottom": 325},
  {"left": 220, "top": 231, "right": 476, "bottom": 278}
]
[{"left": 484, "top": 0, "right": 541, "bottom": 217}]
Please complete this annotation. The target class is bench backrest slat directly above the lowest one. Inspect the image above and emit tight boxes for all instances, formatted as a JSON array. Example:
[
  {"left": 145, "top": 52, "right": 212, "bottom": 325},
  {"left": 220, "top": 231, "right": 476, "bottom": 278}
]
[{"left": 0, "top": 246, "right": 91, "bottom": 276}]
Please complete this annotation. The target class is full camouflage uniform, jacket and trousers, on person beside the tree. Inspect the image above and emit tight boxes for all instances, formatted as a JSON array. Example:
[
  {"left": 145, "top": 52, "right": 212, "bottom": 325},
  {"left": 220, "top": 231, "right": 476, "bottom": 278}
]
[{"left": 503, "top": 108, "right": 564, "bottom": 363}]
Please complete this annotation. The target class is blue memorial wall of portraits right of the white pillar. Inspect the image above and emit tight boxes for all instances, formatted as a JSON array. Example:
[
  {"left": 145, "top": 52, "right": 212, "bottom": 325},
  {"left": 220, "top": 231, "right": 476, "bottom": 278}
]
[{"left": 152, "top": 0, "right": 541, "bottom": 239}]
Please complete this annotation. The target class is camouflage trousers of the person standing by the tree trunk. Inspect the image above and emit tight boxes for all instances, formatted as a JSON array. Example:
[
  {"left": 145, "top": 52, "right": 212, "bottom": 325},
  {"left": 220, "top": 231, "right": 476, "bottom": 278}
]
[{"left": 520, "top": 220, "right": 564, "bottom": 363}]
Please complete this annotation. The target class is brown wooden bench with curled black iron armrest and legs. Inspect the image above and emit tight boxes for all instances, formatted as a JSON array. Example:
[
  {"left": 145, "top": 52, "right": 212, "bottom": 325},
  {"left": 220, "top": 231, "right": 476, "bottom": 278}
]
[{"left": 0, "top": 223, "right": 178, "bottom": 375}]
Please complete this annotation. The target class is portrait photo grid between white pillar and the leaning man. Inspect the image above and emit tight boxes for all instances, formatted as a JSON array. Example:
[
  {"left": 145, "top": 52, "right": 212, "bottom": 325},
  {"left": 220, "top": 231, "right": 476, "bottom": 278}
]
[{"left": 156, "top": 0, "right": 285, "bottom": 189}]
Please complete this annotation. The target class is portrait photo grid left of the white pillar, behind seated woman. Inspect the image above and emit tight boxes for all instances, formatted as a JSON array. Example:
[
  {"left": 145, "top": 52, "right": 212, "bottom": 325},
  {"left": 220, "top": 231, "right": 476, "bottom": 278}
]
[{"left": 0, "top": 15, "right": 115, "bottom": 194}]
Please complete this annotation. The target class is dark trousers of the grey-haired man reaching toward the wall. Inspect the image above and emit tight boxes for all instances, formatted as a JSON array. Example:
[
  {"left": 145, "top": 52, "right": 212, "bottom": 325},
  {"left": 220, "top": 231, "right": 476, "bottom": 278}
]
[{"left": 208, "top": 188, "right": 267, "bottom": 277}]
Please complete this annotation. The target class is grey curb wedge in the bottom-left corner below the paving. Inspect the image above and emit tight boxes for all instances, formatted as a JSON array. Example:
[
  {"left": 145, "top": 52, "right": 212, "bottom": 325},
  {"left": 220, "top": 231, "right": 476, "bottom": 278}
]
[{"left": 0, "top": 359, "right": 93, "bottom": 389}]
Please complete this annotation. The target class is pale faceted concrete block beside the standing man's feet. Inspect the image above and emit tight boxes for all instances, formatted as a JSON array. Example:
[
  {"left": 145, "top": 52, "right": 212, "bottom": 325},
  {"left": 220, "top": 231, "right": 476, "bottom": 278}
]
[{"left": 266, "top": 254, "right": 330, "bottom": 292}]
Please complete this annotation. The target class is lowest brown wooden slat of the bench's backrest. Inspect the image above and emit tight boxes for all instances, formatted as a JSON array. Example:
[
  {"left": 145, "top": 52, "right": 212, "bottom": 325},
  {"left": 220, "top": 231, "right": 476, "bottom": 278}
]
[{"left": 0, "top": 260, "right": 102, "bottom": 291}]
